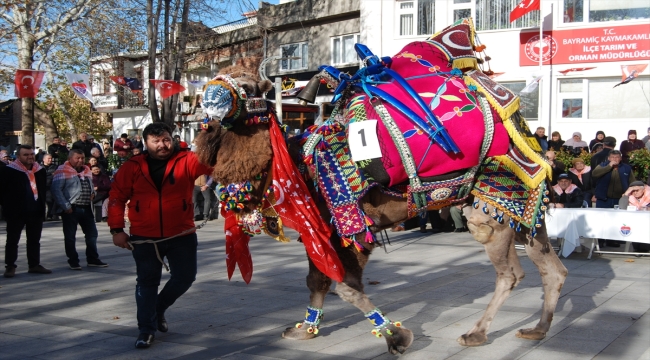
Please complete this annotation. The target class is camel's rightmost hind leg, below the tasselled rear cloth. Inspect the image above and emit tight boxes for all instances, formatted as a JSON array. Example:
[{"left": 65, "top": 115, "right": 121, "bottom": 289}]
[{"left": 516, "top": 225, "right": 568, "bottom": 340}]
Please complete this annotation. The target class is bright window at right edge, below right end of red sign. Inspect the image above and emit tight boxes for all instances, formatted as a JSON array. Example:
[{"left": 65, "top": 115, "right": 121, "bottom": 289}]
[{"left": 587, "top": 76, "right": 650, "bottom": 120}]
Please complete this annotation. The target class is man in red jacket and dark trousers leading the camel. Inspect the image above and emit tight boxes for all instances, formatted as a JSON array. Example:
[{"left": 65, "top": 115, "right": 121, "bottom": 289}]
[{"left": 108, "top": 122, "right": 212, "bottom": 348}]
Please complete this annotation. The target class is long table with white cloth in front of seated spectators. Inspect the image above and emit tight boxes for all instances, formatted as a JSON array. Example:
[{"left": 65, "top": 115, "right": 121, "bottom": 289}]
[{"left": 544, "top": 208, "right": 650, "bottom": 259}]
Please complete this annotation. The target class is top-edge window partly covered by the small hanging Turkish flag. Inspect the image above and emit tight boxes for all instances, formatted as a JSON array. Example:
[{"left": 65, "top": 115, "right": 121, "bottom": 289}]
[{"left": 476, "top": 0, "right": 539, "bottom": 31}]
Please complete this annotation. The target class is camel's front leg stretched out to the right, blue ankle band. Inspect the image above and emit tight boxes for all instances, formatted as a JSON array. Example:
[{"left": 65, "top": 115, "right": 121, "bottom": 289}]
[{"left": 335, "top": 235, "right": 413, "bottom": 355}]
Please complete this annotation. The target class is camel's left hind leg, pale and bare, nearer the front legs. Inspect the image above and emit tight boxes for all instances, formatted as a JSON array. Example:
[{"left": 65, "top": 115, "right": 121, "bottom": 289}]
[{"left": 458, "top": 202, "right": 524, "bottom": 346}]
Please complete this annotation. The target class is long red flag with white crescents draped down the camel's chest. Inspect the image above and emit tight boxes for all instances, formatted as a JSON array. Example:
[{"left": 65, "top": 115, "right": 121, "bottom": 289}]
[{"left": 269, "top": 118, "right": 345, "bottom": 282}]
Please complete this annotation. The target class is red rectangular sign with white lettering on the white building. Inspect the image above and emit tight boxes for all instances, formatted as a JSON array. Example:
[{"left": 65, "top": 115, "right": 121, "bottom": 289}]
[{"left": 519, "top": 24, "right": 650, "bottom": 66}]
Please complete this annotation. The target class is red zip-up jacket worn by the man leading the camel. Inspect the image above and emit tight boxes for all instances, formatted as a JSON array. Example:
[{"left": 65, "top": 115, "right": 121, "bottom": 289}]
[{"left": 108, "top": 150, "right": 212, "bottom": 238}]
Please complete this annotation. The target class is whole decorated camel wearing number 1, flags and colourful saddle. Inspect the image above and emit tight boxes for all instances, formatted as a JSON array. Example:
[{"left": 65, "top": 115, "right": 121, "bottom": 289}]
[{"left": 197, "top": 19, "right": 567, "bottom": 354}]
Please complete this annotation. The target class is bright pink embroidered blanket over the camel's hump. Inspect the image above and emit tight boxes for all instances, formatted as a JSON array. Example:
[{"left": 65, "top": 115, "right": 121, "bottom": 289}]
[{"left": 346, "top": 41, "right": 509, "bottom": 186}]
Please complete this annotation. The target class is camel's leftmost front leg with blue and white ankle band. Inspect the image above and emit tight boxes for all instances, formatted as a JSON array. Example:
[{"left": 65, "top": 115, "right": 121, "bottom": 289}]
[{"left": 282, "top": 259, "right": 332, "bottom": 340}]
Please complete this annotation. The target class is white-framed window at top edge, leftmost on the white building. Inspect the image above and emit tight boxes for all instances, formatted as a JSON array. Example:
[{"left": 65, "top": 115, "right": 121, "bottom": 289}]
[{"left": 397, "top": 0, "right": 435, "bottom": 36}]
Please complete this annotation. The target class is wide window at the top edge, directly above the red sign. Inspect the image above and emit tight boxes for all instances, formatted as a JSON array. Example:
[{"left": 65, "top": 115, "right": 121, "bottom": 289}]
[{"left": 563, "top": 0, "right": 650, "bottom": 23}]
